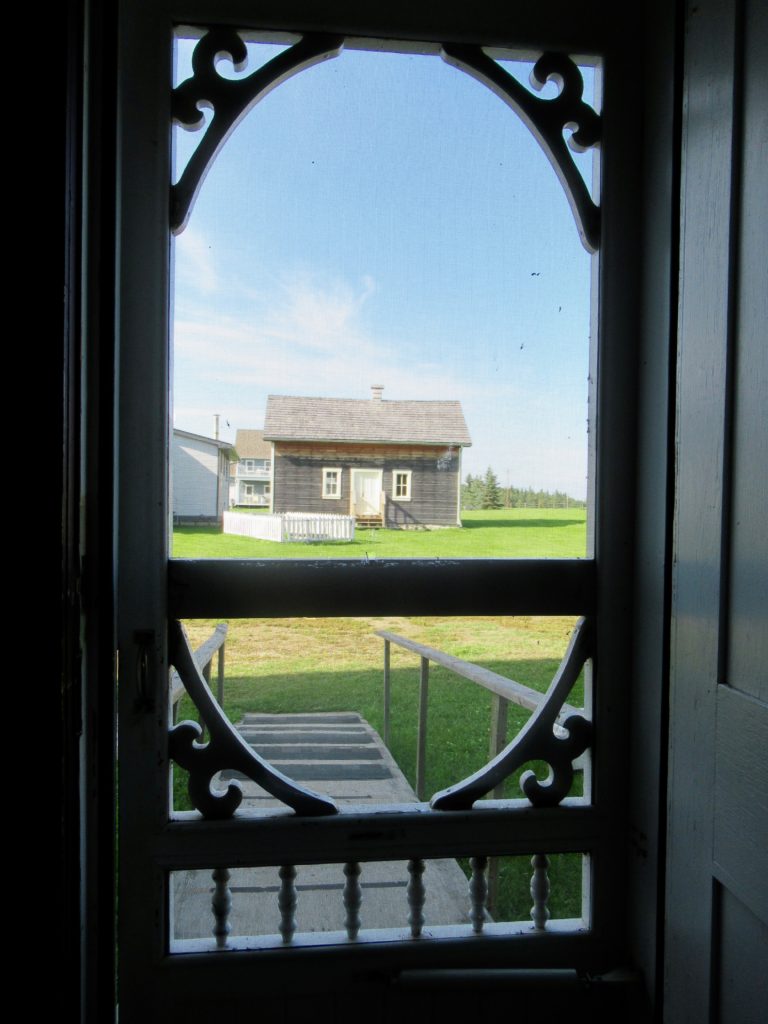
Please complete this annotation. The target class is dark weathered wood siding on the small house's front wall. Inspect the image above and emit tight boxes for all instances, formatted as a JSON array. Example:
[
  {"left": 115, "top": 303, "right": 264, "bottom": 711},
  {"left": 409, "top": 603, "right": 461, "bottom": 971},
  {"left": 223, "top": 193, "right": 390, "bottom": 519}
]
[{"left": 274, "top": 441, "right": 460, "bottom": 527}]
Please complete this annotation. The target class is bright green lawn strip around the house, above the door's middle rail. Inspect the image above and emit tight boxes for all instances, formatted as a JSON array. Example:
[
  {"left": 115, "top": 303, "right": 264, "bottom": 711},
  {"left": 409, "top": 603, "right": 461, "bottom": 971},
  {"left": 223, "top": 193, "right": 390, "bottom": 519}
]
[{"left": 173, "top": 509, "right": 587, "bottom": 558}]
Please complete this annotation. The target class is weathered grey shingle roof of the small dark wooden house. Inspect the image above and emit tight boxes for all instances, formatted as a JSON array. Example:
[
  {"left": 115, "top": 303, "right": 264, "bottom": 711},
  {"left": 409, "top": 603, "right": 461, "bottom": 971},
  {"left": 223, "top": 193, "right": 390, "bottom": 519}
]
[{"left": 264, "top": 394, "right": 472, "bottom": 446}]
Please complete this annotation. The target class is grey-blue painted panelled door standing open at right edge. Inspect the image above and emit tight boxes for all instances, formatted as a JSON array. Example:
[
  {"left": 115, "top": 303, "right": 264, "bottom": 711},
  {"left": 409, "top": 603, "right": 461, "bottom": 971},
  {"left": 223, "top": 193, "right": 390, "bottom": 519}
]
[{"left": 665, "top": 0, "right": 768, "bottom": 1022}]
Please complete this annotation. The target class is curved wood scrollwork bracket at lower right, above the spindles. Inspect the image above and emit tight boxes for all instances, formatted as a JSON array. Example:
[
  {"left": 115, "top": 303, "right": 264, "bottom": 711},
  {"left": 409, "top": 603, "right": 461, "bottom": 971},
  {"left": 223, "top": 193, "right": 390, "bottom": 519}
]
[{"left": 431, "top": 618, "right": 592, "bottom": 811}]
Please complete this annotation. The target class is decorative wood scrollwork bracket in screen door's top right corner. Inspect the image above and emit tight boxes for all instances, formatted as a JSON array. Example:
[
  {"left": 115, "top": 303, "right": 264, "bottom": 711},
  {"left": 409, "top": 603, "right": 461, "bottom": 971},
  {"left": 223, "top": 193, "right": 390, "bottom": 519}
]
[{"left": 441, "top": 43, "right": 601, "bottom": 253}]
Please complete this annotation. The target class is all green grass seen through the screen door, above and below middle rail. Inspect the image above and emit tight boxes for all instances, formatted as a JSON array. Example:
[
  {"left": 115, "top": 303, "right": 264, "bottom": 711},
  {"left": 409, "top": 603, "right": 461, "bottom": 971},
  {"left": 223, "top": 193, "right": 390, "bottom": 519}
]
[{"left": 173, "top": 509, "right": 586, "bottom": 920}]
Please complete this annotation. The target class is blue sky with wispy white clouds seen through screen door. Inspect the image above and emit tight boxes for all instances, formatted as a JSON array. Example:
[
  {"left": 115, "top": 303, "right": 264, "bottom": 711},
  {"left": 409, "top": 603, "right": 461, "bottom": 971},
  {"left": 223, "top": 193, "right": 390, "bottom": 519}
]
[{"left": 173, "top": 42, "right": 592, "bottom": 498}]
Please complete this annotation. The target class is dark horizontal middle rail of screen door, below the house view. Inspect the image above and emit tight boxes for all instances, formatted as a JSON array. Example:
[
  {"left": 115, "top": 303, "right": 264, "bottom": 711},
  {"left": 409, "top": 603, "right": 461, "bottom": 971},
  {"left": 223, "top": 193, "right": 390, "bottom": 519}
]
[{"left": 168, "top": 558, "right": 595, "bottom": 618}]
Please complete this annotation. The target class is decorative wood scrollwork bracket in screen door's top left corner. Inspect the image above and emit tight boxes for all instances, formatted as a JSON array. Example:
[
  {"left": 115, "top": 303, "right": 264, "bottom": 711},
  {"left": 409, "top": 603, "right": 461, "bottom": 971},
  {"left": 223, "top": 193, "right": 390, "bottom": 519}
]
[{"left": 171, "top": 29, "right": 344, "bottom": 234}]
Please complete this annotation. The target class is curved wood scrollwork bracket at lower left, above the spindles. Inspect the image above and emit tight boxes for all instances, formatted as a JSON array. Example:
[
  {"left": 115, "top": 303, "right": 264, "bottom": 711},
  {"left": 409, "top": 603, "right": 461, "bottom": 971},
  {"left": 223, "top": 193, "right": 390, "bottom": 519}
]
[{"left": 168, "top": 620, "right": 338, "bottom": 818}]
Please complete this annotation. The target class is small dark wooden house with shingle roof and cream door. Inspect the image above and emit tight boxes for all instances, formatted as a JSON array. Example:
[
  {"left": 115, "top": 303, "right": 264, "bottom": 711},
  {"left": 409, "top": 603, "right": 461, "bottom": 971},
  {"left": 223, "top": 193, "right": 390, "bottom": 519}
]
[{"left": 264, "top": 386, "right": 472, "bottom": 528}]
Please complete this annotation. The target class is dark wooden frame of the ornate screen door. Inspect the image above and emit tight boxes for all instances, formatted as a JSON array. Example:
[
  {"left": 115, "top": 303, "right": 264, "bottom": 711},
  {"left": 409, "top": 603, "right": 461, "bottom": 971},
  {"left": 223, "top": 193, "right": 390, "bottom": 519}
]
[{"left": 107, "top": 0, "right": 651, "bottom": 1019}]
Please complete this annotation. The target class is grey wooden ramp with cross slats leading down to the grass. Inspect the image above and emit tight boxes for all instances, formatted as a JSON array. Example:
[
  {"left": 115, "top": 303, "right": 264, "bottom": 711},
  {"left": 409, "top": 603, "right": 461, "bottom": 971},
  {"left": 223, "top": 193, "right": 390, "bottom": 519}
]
[{"left": 173, "top": 712, "right": 469, "bottom": 939}]
